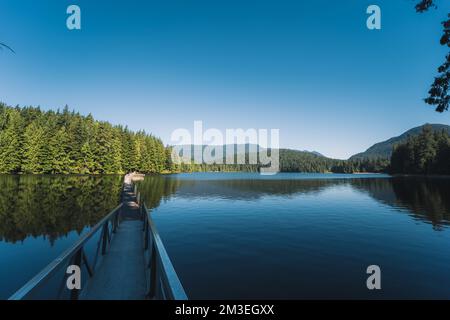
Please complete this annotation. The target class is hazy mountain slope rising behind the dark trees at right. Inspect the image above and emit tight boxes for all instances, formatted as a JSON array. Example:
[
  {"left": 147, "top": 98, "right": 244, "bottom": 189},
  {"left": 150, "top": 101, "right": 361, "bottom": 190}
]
[{"left": 349, "top": 124, "right": 450, "bottom": 160}]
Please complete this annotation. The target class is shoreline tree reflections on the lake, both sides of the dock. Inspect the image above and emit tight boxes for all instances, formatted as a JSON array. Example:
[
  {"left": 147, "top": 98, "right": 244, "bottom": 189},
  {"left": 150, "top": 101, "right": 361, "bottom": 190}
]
[{"left": 0, "top": 174, "right": 450, "bottom": 244}]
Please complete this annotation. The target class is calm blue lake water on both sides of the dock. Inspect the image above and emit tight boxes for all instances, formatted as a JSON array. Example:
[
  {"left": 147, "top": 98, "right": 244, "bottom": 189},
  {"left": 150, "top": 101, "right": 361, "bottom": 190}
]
[{"left": 0, "top": 173, "right": 450, "bottom": 299}]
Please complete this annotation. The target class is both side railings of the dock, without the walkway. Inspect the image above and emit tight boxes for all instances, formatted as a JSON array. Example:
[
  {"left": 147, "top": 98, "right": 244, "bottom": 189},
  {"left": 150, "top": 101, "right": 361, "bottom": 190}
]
[{"left": 9, "top": 185, "right": 188, "bottom": 300}]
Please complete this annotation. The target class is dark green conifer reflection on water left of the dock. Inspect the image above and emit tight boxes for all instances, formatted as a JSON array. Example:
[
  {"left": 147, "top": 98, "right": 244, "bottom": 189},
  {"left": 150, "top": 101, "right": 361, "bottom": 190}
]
[{"left": 0, "top": 175, "right": 122, "bottom": 245}]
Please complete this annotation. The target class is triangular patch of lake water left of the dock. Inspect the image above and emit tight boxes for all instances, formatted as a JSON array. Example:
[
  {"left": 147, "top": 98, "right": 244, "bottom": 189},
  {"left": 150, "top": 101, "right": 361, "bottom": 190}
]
[{"left": 0, "top": 175, "right": 123, "bottom": 299}]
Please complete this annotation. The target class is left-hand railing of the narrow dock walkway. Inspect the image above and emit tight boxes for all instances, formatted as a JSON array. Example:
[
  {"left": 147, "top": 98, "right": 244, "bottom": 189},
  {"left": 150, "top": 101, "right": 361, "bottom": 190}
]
[{"left": 9, "top": 203, "right": 122, "bottom": 300}]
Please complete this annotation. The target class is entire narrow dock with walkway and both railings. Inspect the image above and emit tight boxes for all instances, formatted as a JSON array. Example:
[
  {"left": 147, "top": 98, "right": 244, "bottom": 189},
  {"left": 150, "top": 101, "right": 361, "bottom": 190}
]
[{"left": 10, "top": 175, "right": 187, "bottom": 300}]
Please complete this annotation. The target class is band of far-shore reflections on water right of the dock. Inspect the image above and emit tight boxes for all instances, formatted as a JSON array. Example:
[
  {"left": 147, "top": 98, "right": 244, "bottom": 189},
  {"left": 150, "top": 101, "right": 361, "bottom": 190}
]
[{"left": 140, "top": 174, "right": 450, "bottom": 230}]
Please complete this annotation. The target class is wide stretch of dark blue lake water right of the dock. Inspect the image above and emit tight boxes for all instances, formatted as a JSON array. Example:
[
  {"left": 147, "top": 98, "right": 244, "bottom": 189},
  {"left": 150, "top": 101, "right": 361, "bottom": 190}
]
[{"left": 140, "top": 173, "right": 450, "bottom": 299}]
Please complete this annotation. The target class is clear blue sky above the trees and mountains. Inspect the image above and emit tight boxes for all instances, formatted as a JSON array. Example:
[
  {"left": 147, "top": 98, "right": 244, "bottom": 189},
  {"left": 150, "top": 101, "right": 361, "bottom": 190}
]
[{"left": 0, "top": 0, "right": 450, "bottom": 158}]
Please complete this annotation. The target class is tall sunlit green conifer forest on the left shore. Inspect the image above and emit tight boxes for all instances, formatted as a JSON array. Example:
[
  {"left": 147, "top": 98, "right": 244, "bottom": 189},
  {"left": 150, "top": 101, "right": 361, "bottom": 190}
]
[{"left": 0, "top": 104, "right": 167, "bottom": 174}]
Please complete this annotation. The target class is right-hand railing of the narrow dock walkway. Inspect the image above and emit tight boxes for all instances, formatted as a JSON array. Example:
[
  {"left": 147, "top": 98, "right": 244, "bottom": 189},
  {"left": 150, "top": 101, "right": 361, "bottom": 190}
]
[{"left": 142, "top": 200, "right": 188, "bottom": 300}]
